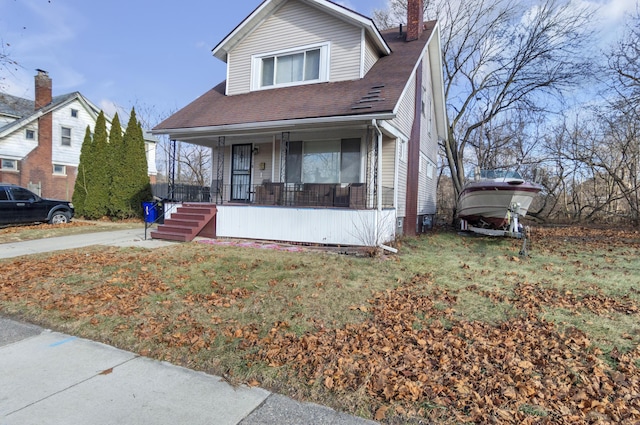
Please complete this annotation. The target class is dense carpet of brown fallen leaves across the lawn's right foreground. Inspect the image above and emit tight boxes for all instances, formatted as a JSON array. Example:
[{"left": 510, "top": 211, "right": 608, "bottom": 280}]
[{"left": 246, "top": 283, "right": 640, "bottom": 424}]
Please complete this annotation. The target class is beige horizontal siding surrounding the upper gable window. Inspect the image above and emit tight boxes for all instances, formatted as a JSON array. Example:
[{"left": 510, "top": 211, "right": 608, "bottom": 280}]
[{"left": 227, "top": 1, "right": 361, "bottom": 95}]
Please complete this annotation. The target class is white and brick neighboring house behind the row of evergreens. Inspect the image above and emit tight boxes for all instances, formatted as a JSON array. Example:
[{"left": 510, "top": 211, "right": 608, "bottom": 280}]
[{"left": 0, "top": 70, "right": 157, "bottom": 200}]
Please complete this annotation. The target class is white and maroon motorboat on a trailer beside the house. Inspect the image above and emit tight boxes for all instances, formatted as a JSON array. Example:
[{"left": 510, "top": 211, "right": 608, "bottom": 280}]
[{"left": 457, "top": 170, "right": 542, "bottom": 237}]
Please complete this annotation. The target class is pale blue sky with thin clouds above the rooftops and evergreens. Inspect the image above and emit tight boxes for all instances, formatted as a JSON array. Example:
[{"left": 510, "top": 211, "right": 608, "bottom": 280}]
[{"left": 0, "top": 0, "right": 636, "bottom": 124}]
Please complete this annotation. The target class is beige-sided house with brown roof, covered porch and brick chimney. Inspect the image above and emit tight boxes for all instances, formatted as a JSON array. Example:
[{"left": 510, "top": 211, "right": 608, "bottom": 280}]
[{"left": 153, "top": 0, "right": 447, "bottom": 246}]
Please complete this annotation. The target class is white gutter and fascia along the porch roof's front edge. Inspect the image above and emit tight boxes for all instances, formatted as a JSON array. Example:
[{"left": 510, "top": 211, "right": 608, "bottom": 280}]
[{"left": 151, "top": 112, "right": 395, "bottom": 140}]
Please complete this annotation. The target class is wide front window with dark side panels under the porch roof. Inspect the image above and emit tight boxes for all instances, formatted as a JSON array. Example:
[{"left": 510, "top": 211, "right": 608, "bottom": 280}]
[{"left": 286, "top": 139, "right": 362, "bottom": 183}]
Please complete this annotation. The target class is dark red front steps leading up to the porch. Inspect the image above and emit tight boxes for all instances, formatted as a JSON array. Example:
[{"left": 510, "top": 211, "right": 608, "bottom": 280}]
[{"left": 151, "top": 203, "right": 217, "bottom": 242}]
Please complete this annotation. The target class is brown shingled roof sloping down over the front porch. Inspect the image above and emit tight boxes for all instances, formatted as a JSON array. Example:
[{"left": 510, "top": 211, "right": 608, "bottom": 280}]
[{"left": 154, "top": 21, "right": 435, "bottom": 131}]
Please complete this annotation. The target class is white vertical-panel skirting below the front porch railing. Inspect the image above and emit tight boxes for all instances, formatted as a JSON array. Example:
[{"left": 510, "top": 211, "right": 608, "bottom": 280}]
[{"left": 216, "top": 205, "right": 395, "bottom": 246}]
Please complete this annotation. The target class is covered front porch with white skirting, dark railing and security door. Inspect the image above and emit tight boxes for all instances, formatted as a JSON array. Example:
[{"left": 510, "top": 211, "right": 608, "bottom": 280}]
[{"left": 158, "top": 121, "right": 401, "bottom": 246}]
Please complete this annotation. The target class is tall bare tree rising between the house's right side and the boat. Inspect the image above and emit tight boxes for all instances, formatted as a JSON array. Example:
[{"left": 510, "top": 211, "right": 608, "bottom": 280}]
[{"left": 375, "top": 0, "right": 592, "bottom": 204}]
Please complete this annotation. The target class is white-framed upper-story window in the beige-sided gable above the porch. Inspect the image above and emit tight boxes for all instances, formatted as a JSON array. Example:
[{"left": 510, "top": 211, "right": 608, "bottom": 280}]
[{"left": 251, "top": 44, "right": 329, "bottom": 90}]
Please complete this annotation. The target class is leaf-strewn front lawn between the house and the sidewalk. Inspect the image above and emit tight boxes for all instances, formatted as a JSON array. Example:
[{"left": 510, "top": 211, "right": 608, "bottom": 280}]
[{"left": 0, "top": 227, "right": 640, "bottom": 424}]
